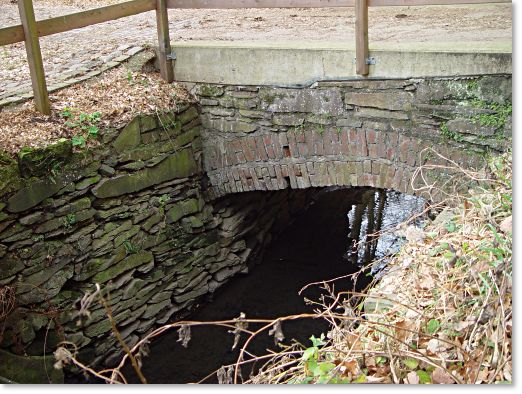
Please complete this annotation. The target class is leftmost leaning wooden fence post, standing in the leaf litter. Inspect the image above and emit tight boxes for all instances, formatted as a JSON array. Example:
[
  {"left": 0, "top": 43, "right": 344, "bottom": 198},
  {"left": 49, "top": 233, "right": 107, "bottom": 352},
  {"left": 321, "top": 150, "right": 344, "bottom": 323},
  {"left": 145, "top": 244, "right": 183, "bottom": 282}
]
[{"left": 18, "top": 0, "right": 51, "bottom": 115}]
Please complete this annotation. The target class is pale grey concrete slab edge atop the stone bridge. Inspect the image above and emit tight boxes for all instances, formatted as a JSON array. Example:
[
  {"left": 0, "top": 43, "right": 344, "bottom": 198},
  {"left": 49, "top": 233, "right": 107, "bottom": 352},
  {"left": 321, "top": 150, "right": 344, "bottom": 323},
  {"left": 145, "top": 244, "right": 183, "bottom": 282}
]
[{"left": 173, "top": 40, "right": 512, "bottom": 86}]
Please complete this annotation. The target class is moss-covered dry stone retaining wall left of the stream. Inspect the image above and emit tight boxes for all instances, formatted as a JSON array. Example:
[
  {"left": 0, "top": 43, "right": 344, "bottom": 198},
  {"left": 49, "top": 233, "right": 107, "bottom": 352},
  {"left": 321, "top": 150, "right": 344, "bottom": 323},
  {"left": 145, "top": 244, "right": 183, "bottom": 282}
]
[{"left": 0, "top": 106, "right": 312, "bottom": 378}]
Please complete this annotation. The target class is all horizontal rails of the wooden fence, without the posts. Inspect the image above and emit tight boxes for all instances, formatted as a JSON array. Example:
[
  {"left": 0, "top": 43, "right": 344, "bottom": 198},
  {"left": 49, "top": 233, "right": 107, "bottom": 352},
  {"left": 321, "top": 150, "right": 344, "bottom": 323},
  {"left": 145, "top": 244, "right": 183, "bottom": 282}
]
[{"left": 0, "top": 0, "right": 504, "bottom": 46}]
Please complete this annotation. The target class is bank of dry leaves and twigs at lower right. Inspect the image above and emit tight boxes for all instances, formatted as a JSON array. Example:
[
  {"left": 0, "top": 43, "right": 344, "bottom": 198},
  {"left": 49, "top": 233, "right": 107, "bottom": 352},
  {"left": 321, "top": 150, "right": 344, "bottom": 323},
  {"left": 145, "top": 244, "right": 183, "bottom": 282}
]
[{"left": 244, "top": 153, "right": 512, "bottom": 384}]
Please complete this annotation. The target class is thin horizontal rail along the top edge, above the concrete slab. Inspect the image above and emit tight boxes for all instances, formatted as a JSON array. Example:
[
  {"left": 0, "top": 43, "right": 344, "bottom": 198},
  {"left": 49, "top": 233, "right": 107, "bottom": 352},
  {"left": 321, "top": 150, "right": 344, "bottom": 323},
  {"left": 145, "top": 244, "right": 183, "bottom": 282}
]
[{"left": 167, "top": 0, "right": 511, "bottom": 9}]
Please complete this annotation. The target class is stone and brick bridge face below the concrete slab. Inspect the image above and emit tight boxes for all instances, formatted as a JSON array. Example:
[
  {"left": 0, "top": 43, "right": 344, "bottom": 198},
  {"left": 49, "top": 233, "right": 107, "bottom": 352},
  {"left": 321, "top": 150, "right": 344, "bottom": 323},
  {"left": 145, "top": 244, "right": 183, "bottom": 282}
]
[{"left": 192, "top": 75, "right": 511, "bottom": 202}]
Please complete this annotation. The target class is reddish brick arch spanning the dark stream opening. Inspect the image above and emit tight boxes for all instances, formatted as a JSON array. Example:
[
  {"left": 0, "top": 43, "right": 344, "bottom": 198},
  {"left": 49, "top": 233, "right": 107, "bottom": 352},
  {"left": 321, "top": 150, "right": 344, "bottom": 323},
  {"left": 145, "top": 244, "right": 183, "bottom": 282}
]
[{"left": 203, "top": 127, "right": 476, "bottom": 202}]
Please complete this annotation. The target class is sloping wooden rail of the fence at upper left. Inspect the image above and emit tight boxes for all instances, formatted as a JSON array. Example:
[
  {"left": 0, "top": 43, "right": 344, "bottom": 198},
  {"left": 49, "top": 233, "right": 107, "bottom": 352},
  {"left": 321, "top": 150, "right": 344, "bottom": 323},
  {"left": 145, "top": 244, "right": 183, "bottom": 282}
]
[{"left": 0, "top": 0, "right": 156, "bottom": 45}]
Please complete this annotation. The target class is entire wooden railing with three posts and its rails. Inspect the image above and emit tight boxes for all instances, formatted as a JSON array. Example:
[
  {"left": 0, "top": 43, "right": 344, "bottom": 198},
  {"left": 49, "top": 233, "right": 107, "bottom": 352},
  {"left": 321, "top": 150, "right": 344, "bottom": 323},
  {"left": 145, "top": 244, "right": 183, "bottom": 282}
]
[{"left": 0, "top": 0, "right": 511, "bottom": 114}]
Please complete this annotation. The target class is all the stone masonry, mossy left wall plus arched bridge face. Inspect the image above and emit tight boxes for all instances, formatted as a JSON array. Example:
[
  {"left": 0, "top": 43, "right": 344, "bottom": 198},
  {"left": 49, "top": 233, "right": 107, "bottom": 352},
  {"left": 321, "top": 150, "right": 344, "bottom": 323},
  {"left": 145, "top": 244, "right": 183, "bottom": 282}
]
[{"left": 0, "top": 75, "right": 511, "bottom": 382}]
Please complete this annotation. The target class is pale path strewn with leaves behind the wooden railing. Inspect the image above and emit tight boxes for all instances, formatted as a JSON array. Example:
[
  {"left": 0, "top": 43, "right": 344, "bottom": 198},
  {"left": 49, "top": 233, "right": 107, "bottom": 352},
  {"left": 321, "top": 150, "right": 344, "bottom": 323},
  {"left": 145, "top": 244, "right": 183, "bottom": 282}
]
[{"left": 0, "top": 0, "right": 512, "bottom": 106}]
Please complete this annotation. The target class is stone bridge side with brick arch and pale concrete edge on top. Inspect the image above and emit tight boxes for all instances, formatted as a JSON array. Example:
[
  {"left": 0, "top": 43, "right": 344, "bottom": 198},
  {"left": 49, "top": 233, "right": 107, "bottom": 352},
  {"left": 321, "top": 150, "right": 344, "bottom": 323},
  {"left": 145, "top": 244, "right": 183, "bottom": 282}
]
[{"left": 176, "top": 43, "right": 511, "bottom": 202}]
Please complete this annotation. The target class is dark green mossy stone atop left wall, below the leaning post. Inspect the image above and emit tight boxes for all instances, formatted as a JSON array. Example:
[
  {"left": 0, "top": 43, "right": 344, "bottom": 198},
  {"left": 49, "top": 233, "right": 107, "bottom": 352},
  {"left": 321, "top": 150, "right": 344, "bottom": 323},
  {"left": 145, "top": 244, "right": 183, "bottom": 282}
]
[{"left": 18, "top": 138, "right": 72, "bottom": 178}]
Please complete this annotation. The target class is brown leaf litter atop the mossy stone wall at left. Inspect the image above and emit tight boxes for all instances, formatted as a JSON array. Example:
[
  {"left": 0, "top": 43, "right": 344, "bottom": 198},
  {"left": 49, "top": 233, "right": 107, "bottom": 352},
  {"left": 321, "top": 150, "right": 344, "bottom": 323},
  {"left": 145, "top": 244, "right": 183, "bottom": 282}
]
[{"left": 0, "top": 57, "right": 191, "bottom": 156}]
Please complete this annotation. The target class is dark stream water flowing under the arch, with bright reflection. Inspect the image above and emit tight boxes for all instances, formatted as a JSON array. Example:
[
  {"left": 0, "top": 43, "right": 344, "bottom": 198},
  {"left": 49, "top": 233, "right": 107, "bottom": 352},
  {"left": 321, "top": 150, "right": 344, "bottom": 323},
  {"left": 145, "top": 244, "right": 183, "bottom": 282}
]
[{"left": 68, "top": 189, "right": 419, "bottom": 383}]
